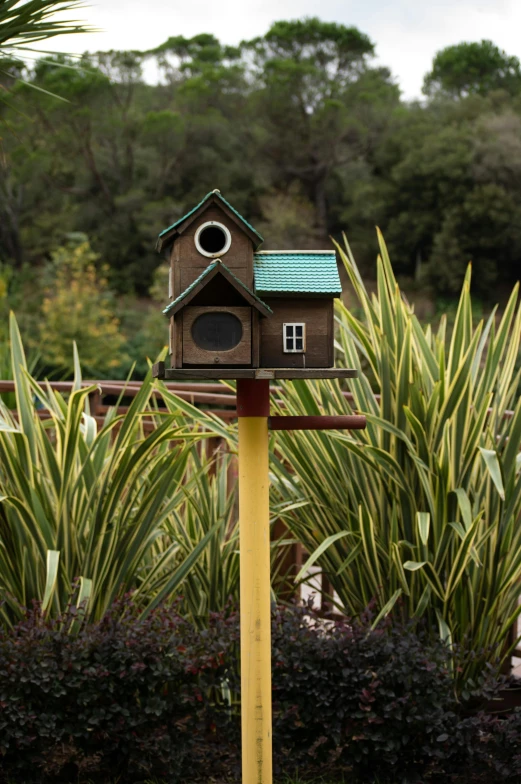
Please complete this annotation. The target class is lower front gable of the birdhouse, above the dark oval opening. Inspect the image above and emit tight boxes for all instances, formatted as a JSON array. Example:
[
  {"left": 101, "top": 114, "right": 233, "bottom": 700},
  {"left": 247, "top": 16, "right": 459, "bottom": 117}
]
[{"left": 163, "top": 260, "right": 271, "bottom": 318}]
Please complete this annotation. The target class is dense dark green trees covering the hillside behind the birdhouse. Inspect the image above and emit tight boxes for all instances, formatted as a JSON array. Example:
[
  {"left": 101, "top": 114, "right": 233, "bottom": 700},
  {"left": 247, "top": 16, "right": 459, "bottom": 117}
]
[{"left": 0, "top": 18, "right": 521, "bottom": 297}]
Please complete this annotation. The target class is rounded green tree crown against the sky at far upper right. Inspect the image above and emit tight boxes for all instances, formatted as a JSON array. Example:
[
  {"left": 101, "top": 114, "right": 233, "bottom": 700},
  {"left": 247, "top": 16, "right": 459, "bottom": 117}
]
[{"left": 423, "top": 40, "right": 521, "bottom": 98}]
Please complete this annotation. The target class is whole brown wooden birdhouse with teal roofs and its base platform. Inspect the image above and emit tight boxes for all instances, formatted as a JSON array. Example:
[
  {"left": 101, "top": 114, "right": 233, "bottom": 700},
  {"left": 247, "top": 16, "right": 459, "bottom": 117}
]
[{"left": 150, "top": 190, "right": 355, "bottom": 379}]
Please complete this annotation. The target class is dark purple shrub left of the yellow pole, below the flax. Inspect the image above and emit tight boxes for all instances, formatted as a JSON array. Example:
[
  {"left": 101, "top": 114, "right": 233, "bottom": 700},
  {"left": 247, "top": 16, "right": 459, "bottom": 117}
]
[{"left": 0, "top": 600, "right": 237, "bottom": 782}]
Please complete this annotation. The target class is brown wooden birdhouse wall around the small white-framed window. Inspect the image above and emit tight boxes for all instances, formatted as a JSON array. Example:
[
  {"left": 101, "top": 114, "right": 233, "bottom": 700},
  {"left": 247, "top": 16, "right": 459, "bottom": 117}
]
[{"left": 260, "top": 297, "right": 334, "bottom": 368}]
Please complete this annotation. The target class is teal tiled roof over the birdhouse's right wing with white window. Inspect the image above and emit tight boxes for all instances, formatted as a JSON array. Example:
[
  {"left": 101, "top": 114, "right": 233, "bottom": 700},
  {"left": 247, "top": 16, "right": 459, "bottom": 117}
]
[{"left": 253, "top": 250, "right": 342, "bottom": 297}]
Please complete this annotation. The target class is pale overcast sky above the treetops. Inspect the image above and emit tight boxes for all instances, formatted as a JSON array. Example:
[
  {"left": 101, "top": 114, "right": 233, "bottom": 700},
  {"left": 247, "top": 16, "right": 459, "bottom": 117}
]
[{"left": 42, "top": 0, "right": 521, "bottom": 98}]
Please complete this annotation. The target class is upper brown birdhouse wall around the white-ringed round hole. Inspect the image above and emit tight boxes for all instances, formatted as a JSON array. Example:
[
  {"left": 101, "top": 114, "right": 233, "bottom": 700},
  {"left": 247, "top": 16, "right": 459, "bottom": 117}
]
[{"left": 170, "top": 204, "right": 253, "bottom": 299}]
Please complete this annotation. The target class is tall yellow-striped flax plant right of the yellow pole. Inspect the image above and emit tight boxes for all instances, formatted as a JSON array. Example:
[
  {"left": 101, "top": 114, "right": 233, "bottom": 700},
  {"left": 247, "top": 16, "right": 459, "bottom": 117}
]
[{"left": 273, "top": 235, "right": 521, "bottom": 677}]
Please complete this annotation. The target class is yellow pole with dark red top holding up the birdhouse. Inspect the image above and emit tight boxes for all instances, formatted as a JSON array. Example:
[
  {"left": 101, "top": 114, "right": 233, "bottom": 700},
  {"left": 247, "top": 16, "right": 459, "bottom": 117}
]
[{"left": 237, "top": 379, "right": 273, "bottom": 784}]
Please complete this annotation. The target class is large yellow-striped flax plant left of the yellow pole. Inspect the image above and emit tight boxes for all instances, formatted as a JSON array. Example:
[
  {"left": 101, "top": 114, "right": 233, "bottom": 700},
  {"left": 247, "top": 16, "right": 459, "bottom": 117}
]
[{"left": 0, "top": 317, "right": 221, "bottom": 624}]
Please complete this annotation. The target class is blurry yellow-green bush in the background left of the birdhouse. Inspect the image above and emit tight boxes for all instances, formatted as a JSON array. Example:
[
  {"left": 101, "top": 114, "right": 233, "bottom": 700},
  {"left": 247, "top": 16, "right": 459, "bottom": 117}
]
[{"left": 0, "top": 243, "right": 168, "bottom": 382}]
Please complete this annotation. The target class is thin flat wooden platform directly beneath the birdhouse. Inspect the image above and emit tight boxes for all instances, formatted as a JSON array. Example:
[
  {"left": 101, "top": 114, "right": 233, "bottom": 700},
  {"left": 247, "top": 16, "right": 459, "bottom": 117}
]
[{"left": 152, "top": 362, "right": 358, "bottom": 381}]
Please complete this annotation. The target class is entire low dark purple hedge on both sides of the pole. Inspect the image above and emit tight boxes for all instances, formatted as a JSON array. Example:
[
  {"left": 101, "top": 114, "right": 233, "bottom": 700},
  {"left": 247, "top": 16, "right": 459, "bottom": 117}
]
[{"left": 0, "top": 599, "right": 521, "bottom": 784}]
